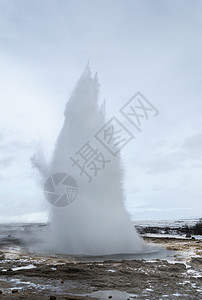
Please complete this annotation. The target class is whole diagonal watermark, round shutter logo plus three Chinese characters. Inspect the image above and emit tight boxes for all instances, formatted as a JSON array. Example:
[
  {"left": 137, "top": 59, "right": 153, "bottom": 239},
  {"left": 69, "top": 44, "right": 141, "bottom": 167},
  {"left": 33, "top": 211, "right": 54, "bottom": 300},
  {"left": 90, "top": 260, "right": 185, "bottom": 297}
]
[{"left": 44, "top": 92, "right": 159, "bottom": 207}]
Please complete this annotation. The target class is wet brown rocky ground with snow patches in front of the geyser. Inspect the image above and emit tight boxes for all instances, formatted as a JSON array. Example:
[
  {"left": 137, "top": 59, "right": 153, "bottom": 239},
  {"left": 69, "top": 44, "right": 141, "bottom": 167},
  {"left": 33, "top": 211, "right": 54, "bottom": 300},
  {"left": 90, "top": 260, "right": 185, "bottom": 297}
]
[{"left": 0, "top": 237, "right": 202, "bottom": 300}]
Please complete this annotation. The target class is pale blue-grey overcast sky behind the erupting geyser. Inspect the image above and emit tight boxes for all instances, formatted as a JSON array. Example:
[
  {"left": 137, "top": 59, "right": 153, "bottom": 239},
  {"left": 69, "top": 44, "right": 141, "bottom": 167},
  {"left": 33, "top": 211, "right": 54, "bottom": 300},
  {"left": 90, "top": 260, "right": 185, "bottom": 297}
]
[{"left": 0, "top": 0, "right": 202, "bottom": 221}]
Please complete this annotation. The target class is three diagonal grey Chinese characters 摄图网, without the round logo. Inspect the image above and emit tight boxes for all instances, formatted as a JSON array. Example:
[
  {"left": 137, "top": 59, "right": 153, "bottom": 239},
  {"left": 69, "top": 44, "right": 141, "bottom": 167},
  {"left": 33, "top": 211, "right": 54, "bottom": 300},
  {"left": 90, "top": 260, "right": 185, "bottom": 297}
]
[{"left": 70, "top": 92, "right": 159, "bottom": 182}]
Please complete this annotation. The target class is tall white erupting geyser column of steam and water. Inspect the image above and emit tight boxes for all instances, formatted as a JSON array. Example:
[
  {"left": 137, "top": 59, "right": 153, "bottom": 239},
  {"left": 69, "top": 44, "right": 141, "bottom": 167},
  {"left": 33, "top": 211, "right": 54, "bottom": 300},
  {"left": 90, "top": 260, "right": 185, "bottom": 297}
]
[{"left": 34, "top": 66, "right": 143, "bottom": 255}]
